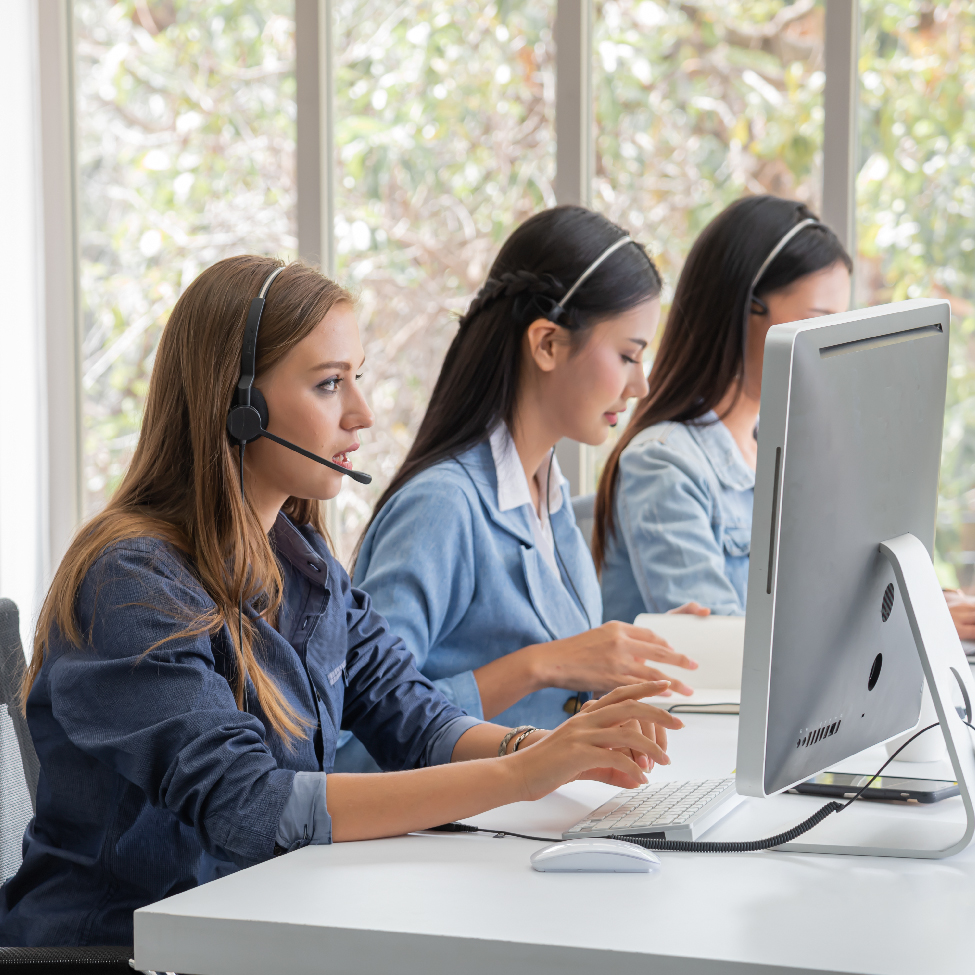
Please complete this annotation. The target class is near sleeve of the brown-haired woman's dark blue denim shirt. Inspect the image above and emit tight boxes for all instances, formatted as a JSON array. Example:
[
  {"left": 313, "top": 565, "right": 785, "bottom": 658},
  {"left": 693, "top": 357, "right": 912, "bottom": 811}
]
[{"left": 50, "top": 544, "right": 295, "bottom": 866}]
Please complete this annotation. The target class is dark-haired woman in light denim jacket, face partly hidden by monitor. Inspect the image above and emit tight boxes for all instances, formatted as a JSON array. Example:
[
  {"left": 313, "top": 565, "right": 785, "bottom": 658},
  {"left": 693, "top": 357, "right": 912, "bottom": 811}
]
[{"left": 593, "top": 196, "right": 853, "bottom": 620}]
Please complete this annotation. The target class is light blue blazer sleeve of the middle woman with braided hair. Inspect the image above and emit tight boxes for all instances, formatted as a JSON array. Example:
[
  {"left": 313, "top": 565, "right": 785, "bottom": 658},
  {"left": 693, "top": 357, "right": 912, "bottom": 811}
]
[{"left": 356, "top": 482, "right": 484, "bottom": 718}]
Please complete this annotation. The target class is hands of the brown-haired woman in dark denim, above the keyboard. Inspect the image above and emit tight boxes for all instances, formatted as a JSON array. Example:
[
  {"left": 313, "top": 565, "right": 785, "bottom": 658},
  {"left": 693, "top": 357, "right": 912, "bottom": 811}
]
[{"left": 504, "top": 681, "right": 684, "bottom": 799}]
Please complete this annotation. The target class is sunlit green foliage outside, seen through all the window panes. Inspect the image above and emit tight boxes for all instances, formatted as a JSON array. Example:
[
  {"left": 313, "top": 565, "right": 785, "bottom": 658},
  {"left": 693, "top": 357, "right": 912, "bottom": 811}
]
[{"left": 74, "top": 0, "right": 975, "bottom": 585}]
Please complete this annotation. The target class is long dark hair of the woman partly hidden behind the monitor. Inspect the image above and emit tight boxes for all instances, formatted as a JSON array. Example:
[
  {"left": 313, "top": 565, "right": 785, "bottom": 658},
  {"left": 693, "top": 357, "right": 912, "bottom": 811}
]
[{"left": 592, "top": 196, "right": 853, "bottom": 569}]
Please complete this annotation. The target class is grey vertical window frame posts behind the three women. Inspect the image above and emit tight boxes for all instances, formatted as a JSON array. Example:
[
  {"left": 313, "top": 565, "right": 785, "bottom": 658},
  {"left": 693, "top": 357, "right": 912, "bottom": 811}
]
[{"left": 38, "top": 0, "right": 859, "bottom": 556}]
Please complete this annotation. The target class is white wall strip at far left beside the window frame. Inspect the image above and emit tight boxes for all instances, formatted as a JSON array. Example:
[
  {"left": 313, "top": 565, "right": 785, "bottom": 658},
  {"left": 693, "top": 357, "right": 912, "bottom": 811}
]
[{"left": 0, "top": 0, "right": 48, "bottom": 644}]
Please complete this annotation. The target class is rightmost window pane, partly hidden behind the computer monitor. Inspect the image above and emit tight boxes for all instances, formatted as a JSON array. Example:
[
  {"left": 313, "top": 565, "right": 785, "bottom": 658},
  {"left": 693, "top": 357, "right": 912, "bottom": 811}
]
[{"left": 856, "top": 0, "right": 975, "bottom": 588}]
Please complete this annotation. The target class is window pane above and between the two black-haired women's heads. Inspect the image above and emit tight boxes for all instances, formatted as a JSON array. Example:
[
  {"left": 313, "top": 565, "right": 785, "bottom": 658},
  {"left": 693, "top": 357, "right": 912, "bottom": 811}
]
[{"left": 593, "top": 0, "right": 825, "bottom": 477}]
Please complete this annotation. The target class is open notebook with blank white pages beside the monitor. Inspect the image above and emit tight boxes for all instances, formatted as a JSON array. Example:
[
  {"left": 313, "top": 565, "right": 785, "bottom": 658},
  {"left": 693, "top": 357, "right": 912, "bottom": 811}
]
[{"left": 633, "top": 613, "right": 745, "bottom": 701}]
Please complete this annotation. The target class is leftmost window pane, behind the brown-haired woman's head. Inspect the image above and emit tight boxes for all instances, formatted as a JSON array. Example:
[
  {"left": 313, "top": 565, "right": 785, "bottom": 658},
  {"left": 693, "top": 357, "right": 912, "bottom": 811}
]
[{"left": 74, "top": 0, "right": 297, "bottom": 517}]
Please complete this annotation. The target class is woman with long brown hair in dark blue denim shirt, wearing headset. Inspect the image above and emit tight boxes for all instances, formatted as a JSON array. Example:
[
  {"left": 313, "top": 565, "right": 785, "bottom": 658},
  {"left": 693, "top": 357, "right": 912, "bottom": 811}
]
[{"left": 0, "top": 257, "right": 680, "bottom": 945}]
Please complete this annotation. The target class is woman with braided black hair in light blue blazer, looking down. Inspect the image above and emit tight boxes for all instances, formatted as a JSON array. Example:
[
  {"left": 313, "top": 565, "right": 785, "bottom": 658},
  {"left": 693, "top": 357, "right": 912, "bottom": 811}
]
[{"left": 336, "top": 206, "right": 696, "bottom": 771}]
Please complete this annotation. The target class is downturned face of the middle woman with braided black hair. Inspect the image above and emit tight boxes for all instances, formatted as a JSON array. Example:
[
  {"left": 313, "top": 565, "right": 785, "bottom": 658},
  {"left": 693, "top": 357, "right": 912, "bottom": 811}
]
[{"left": 535, "top": 298, "right": 660, "bottom": 446}]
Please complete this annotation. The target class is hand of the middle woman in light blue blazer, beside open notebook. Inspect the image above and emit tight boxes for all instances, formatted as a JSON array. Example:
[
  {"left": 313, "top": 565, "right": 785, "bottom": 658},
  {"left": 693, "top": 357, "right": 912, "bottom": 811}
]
[{"left": 519, "top": 620, "right": 709, "bottom": 697}]
